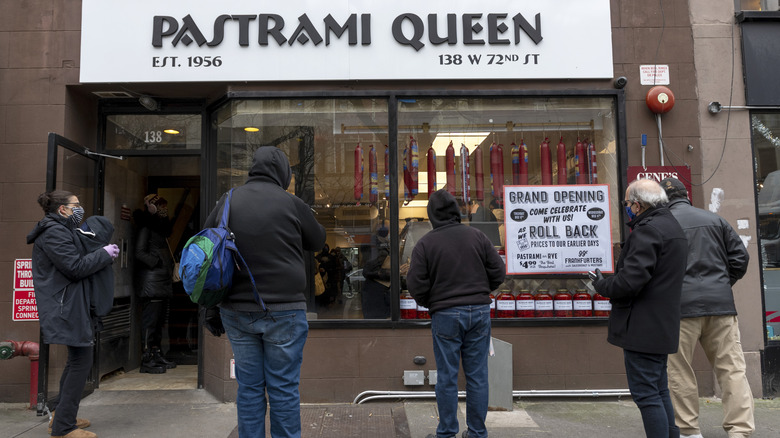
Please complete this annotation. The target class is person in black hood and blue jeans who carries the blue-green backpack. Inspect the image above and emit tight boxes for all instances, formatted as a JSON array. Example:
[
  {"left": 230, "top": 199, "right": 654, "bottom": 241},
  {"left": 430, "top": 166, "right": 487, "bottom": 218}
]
[{"left": 204, "top": 146, "right": 329, "bottom": 438}]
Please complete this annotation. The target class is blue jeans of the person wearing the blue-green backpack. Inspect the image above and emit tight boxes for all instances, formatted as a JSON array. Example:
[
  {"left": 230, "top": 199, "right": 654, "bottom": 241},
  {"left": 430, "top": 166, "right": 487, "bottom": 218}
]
[{"left": 221, "top": 309, "right": 309, "bottom": 438}]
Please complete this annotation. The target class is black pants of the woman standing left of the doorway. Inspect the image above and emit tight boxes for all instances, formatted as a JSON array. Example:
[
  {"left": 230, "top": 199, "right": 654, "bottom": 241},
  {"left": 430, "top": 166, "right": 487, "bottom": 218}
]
[{"left": 51, "top": 345, "right": 93, "bottom": 436}]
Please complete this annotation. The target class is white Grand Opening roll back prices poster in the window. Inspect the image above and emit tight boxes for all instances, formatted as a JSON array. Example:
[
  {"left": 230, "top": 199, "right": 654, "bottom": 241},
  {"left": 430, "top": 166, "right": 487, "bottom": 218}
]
[{"left": 504, "top": 184, "right": 613, "bottom": 274}]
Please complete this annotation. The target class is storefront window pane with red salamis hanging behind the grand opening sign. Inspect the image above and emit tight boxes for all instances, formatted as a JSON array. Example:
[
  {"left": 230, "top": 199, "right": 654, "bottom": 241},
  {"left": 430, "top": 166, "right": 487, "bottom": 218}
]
[{"left": 397, "top": 97, "right": 622, "bottom": 317}]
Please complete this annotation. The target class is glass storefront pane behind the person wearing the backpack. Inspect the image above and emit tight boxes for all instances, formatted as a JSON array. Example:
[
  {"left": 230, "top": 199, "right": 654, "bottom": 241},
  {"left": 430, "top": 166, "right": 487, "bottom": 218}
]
[{"left": 216, "top": 98, "right": 393, "bottom": 319}]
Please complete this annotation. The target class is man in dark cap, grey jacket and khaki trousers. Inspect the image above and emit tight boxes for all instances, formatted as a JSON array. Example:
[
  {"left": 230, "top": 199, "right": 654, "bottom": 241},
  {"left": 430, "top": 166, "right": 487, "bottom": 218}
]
[{"left": 661, "top": 178, "right": 755, "bottom": 438}]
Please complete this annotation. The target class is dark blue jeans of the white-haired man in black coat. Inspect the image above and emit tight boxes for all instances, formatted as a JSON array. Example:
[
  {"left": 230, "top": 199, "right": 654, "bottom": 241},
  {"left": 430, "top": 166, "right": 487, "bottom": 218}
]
[{"left": 623, "top": 350, "right": 680, "bottom": 438}]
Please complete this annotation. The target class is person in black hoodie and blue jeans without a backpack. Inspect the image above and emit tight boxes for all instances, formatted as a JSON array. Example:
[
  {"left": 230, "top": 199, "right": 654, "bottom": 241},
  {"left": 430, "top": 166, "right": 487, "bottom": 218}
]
[{"left": 406, "top": 189, "right": 506, "bottom": 438}]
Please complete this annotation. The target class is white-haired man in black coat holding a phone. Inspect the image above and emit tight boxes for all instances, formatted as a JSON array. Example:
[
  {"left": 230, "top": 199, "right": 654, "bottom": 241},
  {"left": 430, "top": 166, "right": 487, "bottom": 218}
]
[{"left": 591, "top": 179, "right": 688, "bottom": 438}]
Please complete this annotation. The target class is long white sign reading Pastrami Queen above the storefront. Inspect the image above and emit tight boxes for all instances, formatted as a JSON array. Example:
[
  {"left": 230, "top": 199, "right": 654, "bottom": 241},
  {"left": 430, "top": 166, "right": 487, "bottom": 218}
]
[{"left": 80, "top": 0, "right": 613, "bottom": 83}]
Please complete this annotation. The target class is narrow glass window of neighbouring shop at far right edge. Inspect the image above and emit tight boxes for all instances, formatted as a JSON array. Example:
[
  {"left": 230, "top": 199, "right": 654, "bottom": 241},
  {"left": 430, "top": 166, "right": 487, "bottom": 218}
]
[{"left": 751, "top": 113, "right": 780, "bottom": 341}]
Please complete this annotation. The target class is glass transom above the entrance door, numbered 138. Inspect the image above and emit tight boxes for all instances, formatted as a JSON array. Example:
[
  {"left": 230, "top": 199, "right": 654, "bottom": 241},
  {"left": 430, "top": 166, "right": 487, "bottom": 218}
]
[{"left": 105, "top": 114, "right": 202, "bottom": 151}]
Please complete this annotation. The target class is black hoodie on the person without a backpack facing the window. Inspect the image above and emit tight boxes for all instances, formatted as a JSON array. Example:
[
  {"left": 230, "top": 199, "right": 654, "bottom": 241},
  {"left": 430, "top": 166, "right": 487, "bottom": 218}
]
[{"left": 406, "top": 190, "right": 506, "bottom": 314}]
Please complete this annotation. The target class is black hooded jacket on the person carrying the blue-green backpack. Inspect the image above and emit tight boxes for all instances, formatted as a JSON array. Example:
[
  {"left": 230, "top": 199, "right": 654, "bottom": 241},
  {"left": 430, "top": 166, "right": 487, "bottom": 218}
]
[{"left": 205, "top": 146, "right": 325, "bottom": 312}]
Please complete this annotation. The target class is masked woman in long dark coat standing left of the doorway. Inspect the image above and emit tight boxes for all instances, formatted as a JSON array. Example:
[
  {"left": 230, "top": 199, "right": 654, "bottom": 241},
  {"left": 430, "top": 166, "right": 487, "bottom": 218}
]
[{"left": 27, "top": 190, "right": 119, "bottom": 438}]
